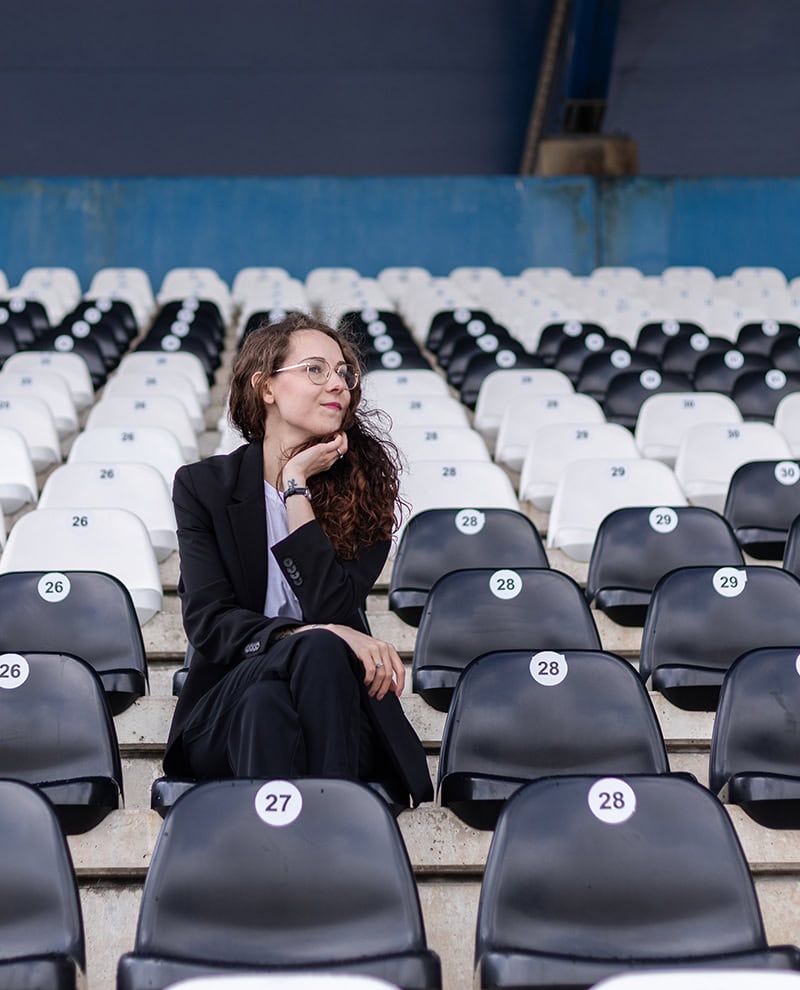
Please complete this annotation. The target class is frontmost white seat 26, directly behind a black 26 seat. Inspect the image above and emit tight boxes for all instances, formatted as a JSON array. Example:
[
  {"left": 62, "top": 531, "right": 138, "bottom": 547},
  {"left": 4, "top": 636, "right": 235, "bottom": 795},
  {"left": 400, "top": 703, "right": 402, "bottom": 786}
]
[{"left": 0, "top": 509, "right": 162, "bottom": 625}]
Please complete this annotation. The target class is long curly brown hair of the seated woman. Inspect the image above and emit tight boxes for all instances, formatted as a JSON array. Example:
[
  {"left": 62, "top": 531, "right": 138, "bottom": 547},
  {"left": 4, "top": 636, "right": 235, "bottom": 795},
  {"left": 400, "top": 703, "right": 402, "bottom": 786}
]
[{"left": 228, "top": 313, "right": 404, "bottom": 558}]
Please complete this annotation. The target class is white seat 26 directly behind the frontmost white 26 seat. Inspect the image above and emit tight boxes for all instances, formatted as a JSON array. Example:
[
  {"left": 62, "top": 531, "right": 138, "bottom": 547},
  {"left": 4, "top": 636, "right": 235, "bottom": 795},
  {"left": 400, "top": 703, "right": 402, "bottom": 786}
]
[{"left": 38, "top": 462, "right": 178, "bottom": 562}]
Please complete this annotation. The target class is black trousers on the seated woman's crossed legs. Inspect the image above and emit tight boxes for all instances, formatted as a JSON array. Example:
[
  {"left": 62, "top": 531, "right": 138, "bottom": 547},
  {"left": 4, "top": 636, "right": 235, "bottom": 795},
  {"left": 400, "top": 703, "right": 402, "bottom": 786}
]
[{"left": 183, "top": 629, "right": 384, "bottom": 780}]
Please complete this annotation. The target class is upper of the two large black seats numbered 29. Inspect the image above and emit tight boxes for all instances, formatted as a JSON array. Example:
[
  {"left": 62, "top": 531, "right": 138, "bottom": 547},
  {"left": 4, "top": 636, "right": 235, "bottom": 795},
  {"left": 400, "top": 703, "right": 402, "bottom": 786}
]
[{"left": 586, "top": 506, "right": 744, "bottom": 626}]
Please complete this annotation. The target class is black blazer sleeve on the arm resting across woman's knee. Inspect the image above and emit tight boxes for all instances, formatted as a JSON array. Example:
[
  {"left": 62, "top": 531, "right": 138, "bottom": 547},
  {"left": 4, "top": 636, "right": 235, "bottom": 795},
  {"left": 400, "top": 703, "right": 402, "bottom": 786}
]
[{"left": 173, "top": 468, "right": 297, "bottom": 666}]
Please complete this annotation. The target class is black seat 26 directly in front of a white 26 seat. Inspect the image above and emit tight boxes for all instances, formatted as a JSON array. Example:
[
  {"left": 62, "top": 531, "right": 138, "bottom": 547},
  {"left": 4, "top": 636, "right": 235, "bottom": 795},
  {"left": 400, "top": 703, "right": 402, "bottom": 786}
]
[{"left": 0, "top": 571, "right": 148, "bottom": 715}]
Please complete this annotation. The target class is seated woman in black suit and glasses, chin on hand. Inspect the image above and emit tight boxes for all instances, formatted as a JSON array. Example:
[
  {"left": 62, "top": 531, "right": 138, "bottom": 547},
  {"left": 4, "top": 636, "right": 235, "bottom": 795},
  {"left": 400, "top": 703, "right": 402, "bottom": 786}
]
[{"left": 164, "top": 316, "right": 432, "bottom": 803}]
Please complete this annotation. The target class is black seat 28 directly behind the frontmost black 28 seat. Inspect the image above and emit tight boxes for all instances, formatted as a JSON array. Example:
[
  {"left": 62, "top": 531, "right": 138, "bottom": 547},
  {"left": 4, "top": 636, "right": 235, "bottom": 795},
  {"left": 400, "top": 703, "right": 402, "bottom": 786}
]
[{"left": 439, "top": 650, "right": 669, "bottom": 829}]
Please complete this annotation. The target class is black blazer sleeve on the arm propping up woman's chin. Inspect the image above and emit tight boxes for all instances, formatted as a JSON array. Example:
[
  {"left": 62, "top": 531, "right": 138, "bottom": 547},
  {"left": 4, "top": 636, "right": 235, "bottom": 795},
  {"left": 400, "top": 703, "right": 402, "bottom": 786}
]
[{"left": 272, "top": 519, "right": 389, "bottom": 625}]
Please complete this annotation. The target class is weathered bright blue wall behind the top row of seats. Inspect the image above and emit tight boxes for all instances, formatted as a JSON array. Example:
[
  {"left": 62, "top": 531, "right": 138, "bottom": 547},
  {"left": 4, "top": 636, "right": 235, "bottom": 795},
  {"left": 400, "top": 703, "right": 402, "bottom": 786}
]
[{"left": 0, "top": 176, "right": 800, "bottom": 286}]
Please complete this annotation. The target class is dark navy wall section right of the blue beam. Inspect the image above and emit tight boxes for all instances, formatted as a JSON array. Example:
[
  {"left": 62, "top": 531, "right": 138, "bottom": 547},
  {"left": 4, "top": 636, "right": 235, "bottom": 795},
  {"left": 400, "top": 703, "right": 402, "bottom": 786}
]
[{"left": 605, "top": 0, "right": 800, "bottom": 176}]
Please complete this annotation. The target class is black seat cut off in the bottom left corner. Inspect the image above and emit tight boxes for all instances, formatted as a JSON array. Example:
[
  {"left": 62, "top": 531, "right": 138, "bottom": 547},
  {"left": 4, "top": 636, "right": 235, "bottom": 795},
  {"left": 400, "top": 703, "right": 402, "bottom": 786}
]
[{"left": 0, "top": 780, "right": 86, "bottom": 990}]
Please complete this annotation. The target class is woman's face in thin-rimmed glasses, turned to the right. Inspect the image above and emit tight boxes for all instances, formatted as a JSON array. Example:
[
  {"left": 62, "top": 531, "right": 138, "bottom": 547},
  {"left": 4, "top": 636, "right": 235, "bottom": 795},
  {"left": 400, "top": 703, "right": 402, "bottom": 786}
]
[{"left": 262, "top": 330, "right": 351, "bottom": 446}]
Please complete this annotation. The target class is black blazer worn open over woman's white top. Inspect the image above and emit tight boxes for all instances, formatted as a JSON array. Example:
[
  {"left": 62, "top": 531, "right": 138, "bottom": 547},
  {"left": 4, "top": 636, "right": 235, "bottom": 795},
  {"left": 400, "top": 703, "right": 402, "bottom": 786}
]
[{"left": 164, "top": 443, "right": 433, "bottom": 804}]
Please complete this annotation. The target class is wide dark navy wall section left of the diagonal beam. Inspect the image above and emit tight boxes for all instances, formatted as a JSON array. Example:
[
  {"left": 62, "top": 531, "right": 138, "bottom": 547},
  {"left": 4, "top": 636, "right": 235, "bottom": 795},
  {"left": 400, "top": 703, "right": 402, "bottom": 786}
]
[{"left": 0, "top": 0, "right": 552, "bottom": 176}]
